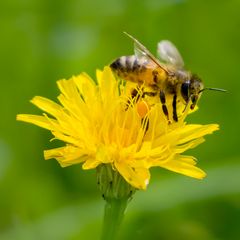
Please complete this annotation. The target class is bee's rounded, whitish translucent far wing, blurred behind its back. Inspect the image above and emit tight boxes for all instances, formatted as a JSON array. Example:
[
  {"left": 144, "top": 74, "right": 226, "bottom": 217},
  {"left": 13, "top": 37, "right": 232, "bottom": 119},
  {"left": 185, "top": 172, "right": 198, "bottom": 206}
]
[{"left": 157, "top": 40, "right": 184, "bottom": 69}]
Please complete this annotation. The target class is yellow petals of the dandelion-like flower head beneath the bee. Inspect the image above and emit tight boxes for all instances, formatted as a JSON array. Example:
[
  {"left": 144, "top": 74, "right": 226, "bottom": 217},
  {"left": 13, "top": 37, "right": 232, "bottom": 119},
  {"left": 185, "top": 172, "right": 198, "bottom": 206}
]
[{"left": 17, "top": 67, "right": 218, "bottom": 189}]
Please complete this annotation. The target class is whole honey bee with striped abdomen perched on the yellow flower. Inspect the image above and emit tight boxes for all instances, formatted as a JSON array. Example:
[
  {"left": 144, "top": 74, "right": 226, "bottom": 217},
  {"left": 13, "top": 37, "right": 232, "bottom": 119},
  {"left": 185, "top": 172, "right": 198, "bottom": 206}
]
[{"left": 110, "top": 32, "right": 225, "bottom": 122}]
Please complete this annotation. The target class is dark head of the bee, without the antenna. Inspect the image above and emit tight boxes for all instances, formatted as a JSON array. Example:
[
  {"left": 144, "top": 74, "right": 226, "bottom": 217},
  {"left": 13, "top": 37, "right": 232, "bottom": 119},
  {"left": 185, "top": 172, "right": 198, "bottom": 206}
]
[{"left": 181, "top": 75, "right": 203, "bottom": 109}]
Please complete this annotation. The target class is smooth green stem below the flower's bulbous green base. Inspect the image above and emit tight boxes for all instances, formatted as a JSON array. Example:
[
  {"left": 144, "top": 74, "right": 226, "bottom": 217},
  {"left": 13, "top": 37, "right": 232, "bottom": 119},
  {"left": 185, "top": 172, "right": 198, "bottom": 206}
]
[{"left": 101, "top": 198, "right": 128, "bottom": 240}]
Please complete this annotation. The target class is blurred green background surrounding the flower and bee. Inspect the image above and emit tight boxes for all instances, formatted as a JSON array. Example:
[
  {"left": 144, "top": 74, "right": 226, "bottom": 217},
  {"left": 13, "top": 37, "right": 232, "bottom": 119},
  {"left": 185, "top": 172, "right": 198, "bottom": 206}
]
[{"left": 0, "top": 0, "right": 240, "bottom": 240}]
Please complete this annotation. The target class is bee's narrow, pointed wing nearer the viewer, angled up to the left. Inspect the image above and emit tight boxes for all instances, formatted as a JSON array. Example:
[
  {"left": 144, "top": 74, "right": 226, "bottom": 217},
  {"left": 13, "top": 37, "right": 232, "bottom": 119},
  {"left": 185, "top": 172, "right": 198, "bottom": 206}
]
[{"left": 124, "top": 32, "right": 169, "bottom": 72}]
